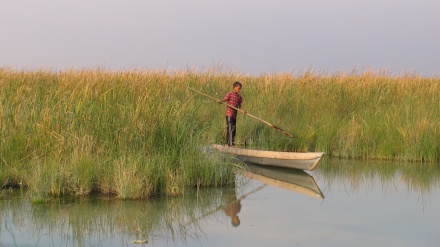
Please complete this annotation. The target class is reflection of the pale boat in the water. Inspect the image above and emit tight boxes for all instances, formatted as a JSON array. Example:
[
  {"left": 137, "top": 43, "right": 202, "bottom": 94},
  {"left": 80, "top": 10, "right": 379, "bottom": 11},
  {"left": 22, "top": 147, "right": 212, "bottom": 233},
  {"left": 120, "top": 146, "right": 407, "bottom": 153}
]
[{"left": 244, "top": 163, "right": 324, "bottom": 199}]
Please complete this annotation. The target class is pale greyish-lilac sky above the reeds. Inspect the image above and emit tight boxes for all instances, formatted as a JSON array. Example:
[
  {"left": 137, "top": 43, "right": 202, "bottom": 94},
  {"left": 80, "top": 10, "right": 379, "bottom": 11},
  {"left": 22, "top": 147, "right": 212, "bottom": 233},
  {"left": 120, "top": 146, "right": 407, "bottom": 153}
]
[{"left": 0, "top": 0, "right": 440, "bottom": 76}]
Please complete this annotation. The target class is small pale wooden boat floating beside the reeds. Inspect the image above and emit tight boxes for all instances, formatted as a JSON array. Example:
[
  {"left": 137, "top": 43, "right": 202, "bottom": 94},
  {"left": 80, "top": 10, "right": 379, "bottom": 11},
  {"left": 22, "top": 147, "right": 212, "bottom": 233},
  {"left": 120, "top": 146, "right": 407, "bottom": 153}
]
[{"left": 212, "top": 144, "right": 324, "bottom": 171}]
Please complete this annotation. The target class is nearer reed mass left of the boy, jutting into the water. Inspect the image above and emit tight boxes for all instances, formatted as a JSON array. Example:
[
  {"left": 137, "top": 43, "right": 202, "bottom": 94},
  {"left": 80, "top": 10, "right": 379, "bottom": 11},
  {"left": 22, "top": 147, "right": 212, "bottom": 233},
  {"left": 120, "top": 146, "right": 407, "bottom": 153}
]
[{"left": 0, "top": 70, "right": 234, "bottom": 201}]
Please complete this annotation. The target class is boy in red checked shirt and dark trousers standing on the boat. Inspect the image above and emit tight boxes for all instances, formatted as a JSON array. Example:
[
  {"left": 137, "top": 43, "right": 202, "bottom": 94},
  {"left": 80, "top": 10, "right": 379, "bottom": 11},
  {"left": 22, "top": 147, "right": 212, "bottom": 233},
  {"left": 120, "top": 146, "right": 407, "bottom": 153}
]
[{"left": 218, "top": 81, "right": 246, "bottom": 147}]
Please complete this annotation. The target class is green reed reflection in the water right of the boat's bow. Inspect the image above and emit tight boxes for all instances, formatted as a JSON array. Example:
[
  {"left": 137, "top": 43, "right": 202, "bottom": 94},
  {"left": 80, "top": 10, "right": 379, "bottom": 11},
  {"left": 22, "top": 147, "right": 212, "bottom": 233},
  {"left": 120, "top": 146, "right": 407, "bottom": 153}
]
[{"left": 314, "top": 159, "right": 440, "bottom": 195}]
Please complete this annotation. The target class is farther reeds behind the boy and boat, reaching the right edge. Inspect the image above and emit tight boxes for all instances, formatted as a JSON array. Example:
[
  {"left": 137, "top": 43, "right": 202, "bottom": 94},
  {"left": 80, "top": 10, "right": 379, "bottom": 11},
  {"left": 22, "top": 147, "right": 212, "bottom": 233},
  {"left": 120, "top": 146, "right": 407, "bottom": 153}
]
[{"left": 190, "top": 72, "right": 440, "bottom": 162}]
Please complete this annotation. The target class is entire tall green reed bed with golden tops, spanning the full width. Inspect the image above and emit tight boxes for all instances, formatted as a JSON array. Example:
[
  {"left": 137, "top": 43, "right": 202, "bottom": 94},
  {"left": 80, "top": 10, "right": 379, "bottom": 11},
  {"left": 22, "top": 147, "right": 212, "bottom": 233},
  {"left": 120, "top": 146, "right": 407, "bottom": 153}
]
[{"left": 0, "top": 69, "right": 440, "bottom": 200}]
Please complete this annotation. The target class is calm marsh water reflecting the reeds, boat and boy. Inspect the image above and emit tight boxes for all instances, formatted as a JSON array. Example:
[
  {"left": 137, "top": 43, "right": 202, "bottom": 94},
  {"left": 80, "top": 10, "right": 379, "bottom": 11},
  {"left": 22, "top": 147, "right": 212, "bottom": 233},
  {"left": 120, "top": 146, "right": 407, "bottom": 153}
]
[{"left": 0, "top": 159, "right": 440, "bottom": 247}]
